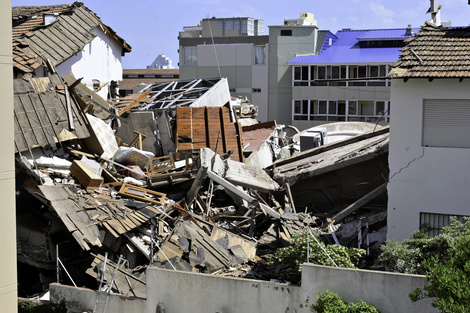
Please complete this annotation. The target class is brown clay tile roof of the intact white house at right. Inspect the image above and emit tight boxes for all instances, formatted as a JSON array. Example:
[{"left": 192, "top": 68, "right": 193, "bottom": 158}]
[{"left": 389, "top": 23, "right": 470, "bottom": 78}]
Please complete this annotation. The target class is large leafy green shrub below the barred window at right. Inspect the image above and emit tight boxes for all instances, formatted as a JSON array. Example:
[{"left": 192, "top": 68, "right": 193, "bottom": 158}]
[{"left": 380, "top": 217, "right": 470, "bottom": 313}]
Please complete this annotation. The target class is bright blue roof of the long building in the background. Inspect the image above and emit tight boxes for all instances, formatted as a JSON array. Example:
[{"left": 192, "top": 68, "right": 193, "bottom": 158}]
[{"left": 287, "top": 28, "right": 419, "bottom": 64}]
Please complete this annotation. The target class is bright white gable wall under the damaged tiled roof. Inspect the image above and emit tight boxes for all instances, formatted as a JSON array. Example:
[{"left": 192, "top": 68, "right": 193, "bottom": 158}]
[{"left": 57, "top": 27, "right": 122, "bottom": 100}]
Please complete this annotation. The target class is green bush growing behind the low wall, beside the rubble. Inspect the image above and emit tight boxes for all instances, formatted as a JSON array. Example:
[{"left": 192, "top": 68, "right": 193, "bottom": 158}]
[{"left": 268, "top": 231, "right": 365, "bottom": 282}]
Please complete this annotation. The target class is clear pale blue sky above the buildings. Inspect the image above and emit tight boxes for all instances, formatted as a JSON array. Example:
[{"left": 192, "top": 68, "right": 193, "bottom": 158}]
[{"left": 11, "top": 0, "right": 470, "bottom": 69}]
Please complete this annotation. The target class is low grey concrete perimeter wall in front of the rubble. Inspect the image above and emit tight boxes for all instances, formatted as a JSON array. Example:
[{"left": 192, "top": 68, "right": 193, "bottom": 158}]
[{"left": 50, "top": 264, "right": 438, "bottom": 313}]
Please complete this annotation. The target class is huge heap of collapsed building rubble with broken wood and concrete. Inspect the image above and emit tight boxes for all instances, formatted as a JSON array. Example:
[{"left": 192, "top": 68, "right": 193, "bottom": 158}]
[{"left": 15, "top": 74, "right": 388, "bottom": 297}]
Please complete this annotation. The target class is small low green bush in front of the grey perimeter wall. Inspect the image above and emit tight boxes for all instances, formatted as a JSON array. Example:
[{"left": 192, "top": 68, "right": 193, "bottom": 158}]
[{"left": 310, "top": 290, "right": 380, "bottom": 313}]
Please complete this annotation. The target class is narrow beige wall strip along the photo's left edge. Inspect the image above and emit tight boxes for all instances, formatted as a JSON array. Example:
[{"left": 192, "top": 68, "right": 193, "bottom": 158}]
[{"left": 0, "top": 1, "right": 18, "bottom": 312}]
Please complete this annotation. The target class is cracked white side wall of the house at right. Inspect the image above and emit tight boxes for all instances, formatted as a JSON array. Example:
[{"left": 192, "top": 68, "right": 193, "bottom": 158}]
[{"left": 387, "top": 79, "right": 470, "bottom": 241}]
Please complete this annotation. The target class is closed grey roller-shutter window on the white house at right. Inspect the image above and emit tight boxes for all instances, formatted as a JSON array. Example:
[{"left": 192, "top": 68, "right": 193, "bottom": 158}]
[{"left": 422, "top": 99, "right": 470, "bottom": 148}]
